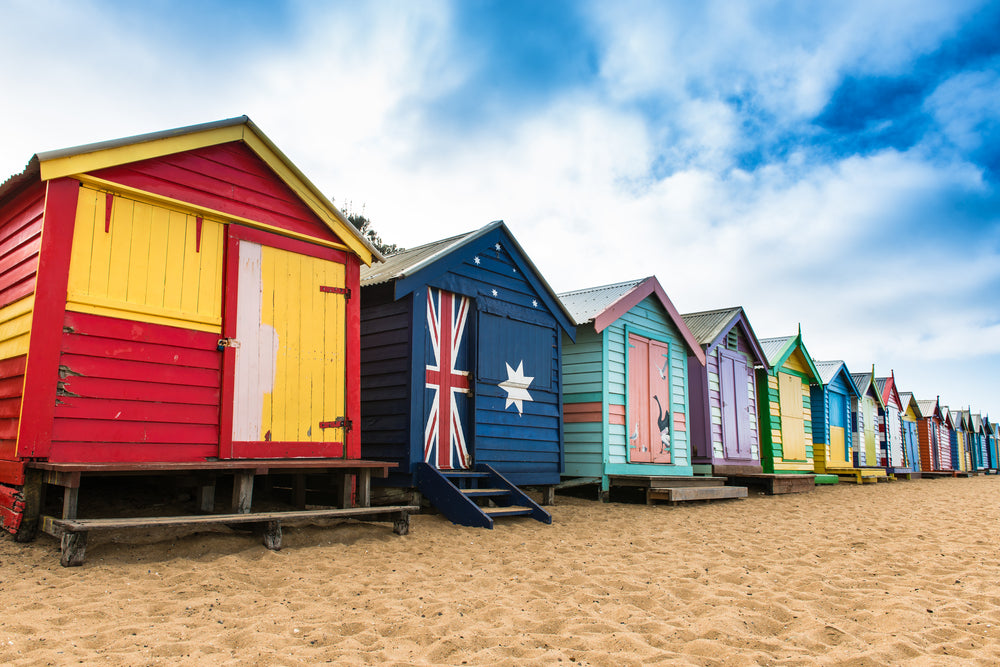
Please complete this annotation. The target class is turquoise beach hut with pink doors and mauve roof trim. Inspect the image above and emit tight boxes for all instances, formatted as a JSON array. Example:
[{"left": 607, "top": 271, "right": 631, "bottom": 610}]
[{"left": 559, "top": 276, "right": 746, "bottom": 502}]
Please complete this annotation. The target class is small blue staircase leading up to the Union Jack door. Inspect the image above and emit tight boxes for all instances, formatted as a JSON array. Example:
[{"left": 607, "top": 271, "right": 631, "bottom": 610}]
[{"left": 417, "top": 463, "right": 552, "bottom": 528}]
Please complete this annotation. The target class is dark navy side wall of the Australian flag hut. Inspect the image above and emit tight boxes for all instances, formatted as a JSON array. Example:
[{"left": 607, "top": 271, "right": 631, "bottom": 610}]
[{"left": 361, "top": 284, "right": 410, "bottom": 471}]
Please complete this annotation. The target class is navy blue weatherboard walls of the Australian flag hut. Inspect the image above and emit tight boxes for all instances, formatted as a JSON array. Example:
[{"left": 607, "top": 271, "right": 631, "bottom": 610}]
[{"left": 362, "top": 223, "right": 575, "bottom": 486}]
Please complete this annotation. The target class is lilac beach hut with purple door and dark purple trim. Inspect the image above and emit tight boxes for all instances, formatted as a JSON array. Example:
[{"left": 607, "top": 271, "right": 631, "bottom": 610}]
[{"left": 682, "top": 307, "right": 767, "bottom": 475}]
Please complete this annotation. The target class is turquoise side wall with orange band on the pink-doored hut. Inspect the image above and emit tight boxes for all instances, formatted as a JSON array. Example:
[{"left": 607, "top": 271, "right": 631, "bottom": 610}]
[{"left": 562, "top": 324, "right": 604, "bottom": 477}]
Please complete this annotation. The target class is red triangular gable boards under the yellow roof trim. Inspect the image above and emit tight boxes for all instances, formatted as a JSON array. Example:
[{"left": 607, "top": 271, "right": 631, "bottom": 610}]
[{"left": 93, "top": 141, "right": 339, "bottom": 247}]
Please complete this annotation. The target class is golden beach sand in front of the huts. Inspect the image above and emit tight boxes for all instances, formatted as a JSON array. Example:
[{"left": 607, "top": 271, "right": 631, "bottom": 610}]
[{"left": 0, "top": 477, "right": 1000, "bottom": 665}]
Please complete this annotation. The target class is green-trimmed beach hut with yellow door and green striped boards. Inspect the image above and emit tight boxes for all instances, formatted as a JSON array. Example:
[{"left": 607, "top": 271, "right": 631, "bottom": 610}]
[{"left": 756, "top": 331, "right": 823, "bottom": 491}]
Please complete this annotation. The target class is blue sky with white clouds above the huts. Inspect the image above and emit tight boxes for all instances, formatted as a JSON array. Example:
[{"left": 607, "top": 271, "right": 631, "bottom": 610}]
[{"left": 0, "top": 0, "right": 1000, "bottom": 412}]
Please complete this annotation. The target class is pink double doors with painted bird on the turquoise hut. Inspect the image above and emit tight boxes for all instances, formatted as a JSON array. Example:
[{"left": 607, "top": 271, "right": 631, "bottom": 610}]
[{"left": 627, "top": 334, "right": 672, "bottom": 463}]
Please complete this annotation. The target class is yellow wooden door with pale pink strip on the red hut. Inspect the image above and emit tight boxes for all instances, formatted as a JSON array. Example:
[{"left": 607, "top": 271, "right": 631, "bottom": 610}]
[{"left": 227, "top": 238, "right": 348, "bottom": 458}]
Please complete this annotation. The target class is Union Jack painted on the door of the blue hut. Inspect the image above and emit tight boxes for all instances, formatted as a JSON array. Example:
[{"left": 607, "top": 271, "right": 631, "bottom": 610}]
[{"left": 424, "top": 288, "right": 470, "bottom": 470}]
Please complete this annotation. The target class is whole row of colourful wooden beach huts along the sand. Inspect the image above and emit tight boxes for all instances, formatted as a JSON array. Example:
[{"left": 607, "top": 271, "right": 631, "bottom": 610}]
[{"left": 0, "top": 117, "right": 1000, "bottom": 565}]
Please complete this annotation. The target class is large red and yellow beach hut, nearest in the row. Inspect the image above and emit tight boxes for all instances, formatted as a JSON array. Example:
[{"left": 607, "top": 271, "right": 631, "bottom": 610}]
[{"left": 0, "top": 116, "right": 418, "bottom": 560}]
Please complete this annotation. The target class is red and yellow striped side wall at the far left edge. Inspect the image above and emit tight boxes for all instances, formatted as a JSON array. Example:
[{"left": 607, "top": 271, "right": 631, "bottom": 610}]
[{"left": 0, "top": 183, "right": 45, "bottom": 459}]
